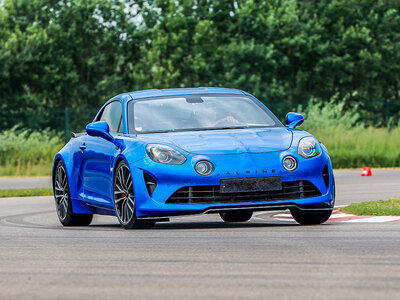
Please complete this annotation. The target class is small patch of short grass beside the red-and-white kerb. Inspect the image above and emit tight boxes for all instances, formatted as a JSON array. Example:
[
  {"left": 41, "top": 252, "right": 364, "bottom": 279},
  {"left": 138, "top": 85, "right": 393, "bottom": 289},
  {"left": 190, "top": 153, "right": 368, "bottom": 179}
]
[{"left": 340, "top": 198, "right": 400, "bottom": 216}]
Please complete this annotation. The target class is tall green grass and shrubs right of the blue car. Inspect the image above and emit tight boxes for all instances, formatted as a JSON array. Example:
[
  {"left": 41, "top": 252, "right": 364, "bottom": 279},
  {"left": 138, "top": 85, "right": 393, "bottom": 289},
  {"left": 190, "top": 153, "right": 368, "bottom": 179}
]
[{"left": 298, "top": 99, "right": 400, "bottom": 168}]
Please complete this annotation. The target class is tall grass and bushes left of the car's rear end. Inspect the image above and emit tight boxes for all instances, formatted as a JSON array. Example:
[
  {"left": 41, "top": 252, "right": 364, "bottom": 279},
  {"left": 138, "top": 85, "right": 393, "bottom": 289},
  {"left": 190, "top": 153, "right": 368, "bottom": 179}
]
[{"left": 0, "top": 127, "right": 63, "bottom": 176}]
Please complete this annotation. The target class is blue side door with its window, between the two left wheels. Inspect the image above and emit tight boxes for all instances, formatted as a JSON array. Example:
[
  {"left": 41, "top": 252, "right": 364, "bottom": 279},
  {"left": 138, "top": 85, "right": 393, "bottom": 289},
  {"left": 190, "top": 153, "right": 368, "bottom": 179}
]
[{"left": 80, "top": 100, "right": 123, "bottom": 208}]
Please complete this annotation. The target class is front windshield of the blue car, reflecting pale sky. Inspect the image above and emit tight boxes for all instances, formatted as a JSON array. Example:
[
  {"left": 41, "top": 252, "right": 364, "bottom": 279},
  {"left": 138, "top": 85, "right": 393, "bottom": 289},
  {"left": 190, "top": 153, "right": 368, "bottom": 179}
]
[{"left": 128, "top": 95, "right": 282, "bottom": 133}]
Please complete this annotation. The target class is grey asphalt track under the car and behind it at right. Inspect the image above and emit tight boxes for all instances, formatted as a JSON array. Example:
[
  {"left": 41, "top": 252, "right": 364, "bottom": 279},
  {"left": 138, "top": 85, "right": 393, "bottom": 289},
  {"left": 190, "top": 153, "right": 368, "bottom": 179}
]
[{"left": 0, "top": 170, "right": 400, "bottom": 299}]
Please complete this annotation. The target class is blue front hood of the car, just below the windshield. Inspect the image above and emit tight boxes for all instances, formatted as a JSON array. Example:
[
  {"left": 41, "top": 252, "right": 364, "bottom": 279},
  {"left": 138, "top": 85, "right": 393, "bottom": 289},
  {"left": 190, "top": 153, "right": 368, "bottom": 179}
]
[{"left": 137, "top": 127, "right": 293, "bottom": 155}]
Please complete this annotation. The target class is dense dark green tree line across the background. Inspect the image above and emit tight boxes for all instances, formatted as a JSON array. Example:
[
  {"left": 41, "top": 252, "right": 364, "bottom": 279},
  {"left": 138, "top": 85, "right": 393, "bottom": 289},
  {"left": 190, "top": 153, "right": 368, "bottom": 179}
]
[{"left": 0, "top": 0, "right": 400, "bottom": 125}]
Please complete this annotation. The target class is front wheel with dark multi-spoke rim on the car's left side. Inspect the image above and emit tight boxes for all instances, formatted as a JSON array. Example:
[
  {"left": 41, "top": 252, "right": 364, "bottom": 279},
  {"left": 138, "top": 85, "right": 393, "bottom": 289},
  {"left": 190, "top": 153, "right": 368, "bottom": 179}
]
[{"left": 113, "top": 160, "right": 156, "bottom": 229}]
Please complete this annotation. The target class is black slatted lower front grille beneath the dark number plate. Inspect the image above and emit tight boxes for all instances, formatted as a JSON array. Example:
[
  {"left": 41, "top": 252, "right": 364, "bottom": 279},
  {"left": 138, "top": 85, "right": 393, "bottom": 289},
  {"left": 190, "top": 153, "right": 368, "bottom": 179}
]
[{"left": 165, "top": 180, "right": 321, "bottom": 204}]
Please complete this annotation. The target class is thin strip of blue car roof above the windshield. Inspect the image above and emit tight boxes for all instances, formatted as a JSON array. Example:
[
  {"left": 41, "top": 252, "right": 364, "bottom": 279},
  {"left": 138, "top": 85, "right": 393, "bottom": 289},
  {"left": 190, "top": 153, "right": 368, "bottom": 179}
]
[{"left": 116, "top": 87, "right": 247, "bottom": 101}]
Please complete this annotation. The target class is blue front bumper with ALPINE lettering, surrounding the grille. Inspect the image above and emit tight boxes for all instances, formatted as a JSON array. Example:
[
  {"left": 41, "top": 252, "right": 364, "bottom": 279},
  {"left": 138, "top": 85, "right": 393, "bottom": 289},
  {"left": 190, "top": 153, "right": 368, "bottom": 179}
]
[{"left": 130, "top": 148, "right": 335, "bottom": 218}]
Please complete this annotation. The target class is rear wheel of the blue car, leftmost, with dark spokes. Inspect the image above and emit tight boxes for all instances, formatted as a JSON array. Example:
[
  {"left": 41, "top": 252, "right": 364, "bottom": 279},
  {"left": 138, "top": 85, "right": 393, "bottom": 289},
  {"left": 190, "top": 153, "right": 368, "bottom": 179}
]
[{"left": 53, "top": 160, "right": 93, "bottom": 226}]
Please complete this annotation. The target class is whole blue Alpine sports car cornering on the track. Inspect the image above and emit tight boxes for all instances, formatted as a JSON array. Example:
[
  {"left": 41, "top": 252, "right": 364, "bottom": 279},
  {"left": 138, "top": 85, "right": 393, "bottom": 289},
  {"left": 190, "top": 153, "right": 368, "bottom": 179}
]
[{"left": 53, "top": 88, "right": 335, "bottom": 229}]
